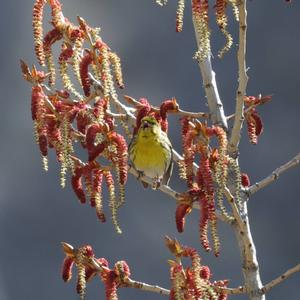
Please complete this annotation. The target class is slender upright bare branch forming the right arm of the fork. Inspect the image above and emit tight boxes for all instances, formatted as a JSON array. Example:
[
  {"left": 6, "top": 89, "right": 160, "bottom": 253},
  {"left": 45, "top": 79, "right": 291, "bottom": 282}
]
[{"left": 228, "top": 0, "right": 248, "bottom": 157}]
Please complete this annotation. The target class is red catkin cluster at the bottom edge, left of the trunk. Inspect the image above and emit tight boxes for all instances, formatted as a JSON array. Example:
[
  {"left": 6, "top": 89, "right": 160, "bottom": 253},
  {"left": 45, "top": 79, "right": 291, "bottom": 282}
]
[{"left": 165, "top": 237, "right": 228, "bottom": 300}]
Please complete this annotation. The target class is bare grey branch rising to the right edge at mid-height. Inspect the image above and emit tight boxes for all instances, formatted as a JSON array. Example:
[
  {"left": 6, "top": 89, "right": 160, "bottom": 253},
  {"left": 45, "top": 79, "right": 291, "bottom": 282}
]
[{"left": 246, "top": 152, "right": 300, "bottom": 196}]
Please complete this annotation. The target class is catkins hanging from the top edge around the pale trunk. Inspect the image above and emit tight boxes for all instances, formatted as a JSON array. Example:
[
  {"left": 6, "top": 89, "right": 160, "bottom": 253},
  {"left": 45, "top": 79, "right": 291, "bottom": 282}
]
[{"left": 156, "top": 0, "right": 239, "bottom": 61}]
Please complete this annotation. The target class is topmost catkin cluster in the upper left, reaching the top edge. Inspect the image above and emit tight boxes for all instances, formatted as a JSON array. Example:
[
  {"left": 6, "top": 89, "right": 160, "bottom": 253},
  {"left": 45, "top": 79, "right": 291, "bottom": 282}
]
[{"left": 33, "top": 0, "right": 124, "bottom": 101}]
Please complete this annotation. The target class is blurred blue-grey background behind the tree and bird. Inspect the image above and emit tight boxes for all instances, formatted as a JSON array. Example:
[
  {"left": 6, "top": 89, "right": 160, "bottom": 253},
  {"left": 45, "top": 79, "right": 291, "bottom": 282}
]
[{"left": 0, "top": 0, "right": 300, "bottom": 300}]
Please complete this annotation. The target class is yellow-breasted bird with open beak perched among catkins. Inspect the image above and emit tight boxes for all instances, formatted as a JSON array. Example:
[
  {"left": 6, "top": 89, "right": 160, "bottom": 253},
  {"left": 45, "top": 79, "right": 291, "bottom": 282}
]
[{"left": 129, "top": 116, "right": 173, "bottom": 189}]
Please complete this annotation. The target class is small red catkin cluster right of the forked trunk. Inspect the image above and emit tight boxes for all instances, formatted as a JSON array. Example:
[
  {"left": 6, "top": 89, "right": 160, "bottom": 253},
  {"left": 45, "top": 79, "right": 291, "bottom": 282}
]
[{"left": 244, "top": 96, "right": 272, "bottom": 145}]
